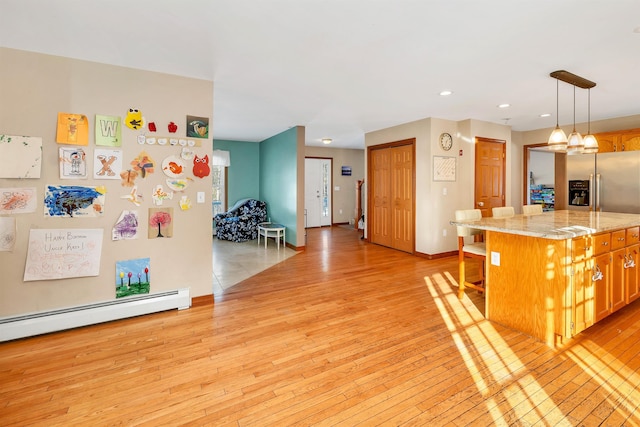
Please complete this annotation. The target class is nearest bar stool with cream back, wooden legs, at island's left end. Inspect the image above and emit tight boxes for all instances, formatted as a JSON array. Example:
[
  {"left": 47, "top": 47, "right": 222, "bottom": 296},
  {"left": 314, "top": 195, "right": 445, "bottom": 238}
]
[{"left": 456, "top": 209, "right": 487, "bottom": 299}]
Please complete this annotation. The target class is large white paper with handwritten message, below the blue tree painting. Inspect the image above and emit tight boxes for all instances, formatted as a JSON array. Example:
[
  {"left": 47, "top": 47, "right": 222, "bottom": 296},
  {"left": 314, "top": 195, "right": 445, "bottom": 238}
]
[{"left": 24, "top": 228, "right": 104, "bottom": 282}]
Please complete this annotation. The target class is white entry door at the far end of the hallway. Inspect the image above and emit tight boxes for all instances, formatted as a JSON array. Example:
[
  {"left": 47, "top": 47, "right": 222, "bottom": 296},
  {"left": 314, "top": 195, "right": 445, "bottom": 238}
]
[{"left": 304, "top": 158, "right": 331, "bottom": 227}]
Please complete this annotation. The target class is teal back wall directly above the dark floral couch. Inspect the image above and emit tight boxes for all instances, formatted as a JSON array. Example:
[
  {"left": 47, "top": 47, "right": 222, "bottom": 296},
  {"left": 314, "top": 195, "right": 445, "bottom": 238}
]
[{"left": 213, "top": 139, "right": 260, "bottom": 207}]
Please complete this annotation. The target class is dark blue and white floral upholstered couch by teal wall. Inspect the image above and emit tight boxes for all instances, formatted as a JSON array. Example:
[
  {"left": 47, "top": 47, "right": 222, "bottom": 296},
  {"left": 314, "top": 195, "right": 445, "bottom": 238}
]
[{"left": 213, "top": 199, "right": 267, "bottom": 242}]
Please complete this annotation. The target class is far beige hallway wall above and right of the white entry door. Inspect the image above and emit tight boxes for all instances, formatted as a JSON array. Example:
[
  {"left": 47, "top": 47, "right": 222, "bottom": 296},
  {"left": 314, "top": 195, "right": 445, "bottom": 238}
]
[{"left": 303, "top": 147, "right": 366, "bottom": 224}]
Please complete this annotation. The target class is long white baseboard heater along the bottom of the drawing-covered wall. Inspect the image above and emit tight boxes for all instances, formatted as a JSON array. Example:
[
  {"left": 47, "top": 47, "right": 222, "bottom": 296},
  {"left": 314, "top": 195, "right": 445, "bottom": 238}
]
[{"left": 0, "top": 288, "right": 191, "bottom": 342}]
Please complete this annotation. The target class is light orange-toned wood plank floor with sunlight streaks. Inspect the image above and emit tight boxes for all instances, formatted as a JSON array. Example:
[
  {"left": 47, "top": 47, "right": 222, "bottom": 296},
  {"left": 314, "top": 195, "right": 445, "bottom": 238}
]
[{"left": 0, "top": 227, "right": 640, "bottom": 426}]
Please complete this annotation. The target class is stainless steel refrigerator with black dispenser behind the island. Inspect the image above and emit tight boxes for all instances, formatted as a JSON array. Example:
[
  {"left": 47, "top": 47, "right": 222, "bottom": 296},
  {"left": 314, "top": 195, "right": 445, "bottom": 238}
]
[{"left": 567, "top": 151, "right": 640, "bottom": 213}]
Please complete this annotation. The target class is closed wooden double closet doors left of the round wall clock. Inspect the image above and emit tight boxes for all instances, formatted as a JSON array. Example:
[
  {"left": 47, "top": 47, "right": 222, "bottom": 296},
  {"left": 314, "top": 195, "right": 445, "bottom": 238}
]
[{"left": 366, "top": 140, "right": 415, "bottom": 253}]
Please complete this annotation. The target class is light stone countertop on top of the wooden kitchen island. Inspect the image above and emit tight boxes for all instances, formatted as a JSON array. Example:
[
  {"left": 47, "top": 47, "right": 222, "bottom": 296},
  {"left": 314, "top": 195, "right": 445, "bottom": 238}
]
[{"left": 451, "top": 210, "right": 640, "bottom": 240}]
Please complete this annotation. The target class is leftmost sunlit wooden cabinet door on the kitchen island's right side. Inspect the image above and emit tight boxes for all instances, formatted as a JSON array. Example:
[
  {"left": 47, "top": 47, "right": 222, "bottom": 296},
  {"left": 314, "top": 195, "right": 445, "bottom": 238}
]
[{"left": 572, "top": 259, "right": 597, "bottom": 335}]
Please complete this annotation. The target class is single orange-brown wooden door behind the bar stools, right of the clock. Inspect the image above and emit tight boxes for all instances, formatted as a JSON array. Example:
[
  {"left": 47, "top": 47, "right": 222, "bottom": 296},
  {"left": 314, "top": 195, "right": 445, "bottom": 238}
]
[{"left": 474, "top": 137, "right": 506, "bottom": 217}]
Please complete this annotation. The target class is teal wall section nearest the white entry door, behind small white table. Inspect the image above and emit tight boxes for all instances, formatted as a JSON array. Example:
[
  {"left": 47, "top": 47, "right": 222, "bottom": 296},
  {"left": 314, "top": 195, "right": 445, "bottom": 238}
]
[{"left": 260, "top": 127, "right": 298, "bottom": 244}]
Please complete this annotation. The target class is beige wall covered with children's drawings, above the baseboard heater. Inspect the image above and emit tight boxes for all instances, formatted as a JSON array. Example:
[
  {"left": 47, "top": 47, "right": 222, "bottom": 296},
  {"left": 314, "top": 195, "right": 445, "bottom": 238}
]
[{"left": 0, "top": 48, "right": 213, "bottom": 317}]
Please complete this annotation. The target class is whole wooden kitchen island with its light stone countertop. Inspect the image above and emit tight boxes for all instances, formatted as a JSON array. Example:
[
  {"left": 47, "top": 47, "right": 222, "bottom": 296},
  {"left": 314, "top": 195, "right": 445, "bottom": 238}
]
[{"left": 451, "top": 211, "right": 640, "bottom": 345}]
